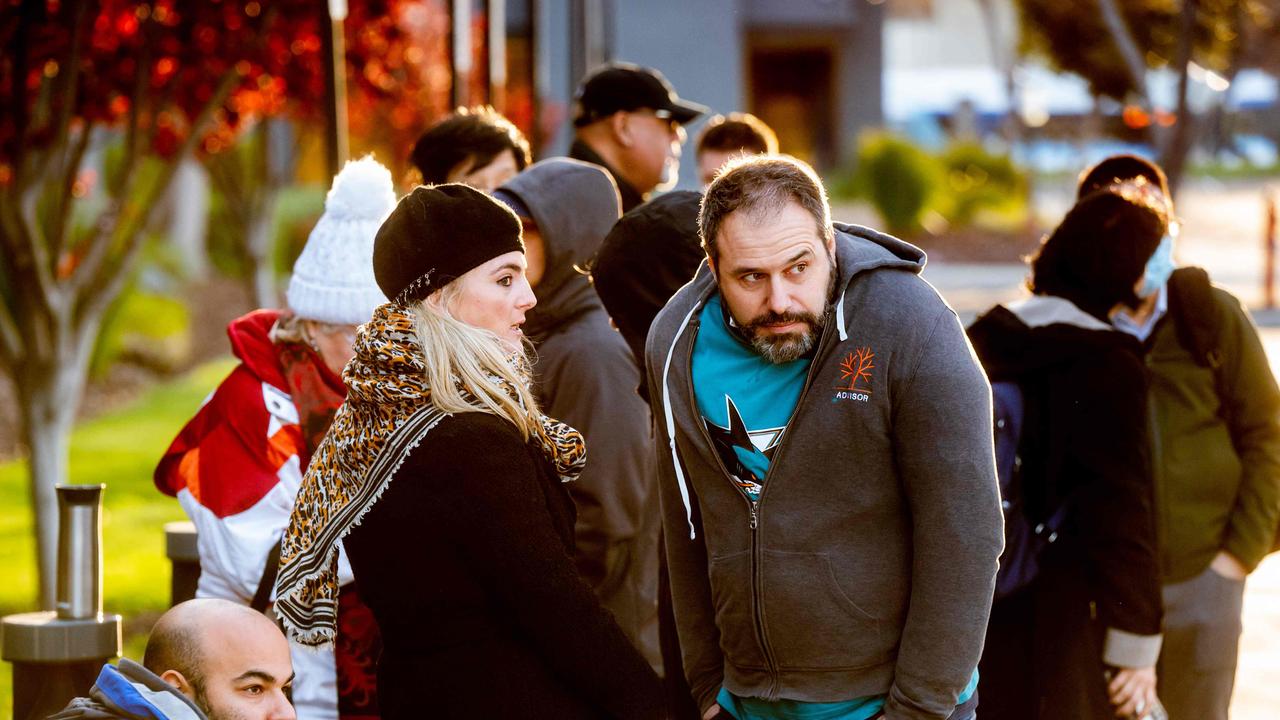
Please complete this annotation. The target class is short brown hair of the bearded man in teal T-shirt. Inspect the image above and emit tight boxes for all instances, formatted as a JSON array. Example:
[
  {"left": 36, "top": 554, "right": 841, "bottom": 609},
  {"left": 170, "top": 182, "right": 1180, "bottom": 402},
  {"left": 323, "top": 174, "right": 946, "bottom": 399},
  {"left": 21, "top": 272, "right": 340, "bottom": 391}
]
[{"left": 698, "top": 155, "right": 836, "bottom": 263}]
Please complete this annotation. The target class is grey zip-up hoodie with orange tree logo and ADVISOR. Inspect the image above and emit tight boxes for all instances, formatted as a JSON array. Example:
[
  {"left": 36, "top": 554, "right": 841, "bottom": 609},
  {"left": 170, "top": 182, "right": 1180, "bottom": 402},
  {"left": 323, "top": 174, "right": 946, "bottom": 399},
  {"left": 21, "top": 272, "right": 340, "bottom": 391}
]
[{"left": 646, "top": 224, "right": 1004, "bottom": 719}]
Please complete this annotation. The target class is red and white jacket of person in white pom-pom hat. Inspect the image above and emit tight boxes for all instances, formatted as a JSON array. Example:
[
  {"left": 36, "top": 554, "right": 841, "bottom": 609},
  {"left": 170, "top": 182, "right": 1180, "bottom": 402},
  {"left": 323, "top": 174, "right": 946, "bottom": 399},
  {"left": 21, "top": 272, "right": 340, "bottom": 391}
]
[{"left": 155, "top": 310, "right": 352, "bottom": 720}]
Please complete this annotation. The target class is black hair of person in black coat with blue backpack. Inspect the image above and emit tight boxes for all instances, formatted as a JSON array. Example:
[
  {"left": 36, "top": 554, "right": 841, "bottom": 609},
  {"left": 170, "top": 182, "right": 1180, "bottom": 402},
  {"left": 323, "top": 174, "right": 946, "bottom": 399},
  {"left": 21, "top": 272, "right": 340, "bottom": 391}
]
[{"left": 1028, "top": 190, "right": 1169, "bottom": 319}]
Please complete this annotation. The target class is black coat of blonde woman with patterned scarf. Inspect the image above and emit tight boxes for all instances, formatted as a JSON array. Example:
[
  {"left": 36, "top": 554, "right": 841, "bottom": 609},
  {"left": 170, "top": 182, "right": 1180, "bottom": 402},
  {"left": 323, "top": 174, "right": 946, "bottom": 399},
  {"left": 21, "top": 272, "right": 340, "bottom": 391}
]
[{"left": 344, "top": 413, "right": 660, "bottom": 720}]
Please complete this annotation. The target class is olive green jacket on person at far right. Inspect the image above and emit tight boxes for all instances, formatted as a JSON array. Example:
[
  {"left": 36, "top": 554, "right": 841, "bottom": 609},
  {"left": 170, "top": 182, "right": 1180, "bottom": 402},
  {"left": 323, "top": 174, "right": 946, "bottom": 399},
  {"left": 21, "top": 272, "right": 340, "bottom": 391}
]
[{"left": 1146, "top": 287, "right": 1280, "bottom": 583}]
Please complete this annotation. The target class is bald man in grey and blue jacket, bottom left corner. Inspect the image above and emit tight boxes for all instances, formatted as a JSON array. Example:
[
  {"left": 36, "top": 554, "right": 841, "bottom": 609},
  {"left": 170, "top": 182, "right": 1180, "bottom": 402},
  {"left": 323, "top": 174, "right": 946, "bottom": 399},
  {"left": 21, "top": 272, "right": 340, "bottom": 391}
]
[{"left": 49, "top": 600, "right": 296, "bottom": 720}]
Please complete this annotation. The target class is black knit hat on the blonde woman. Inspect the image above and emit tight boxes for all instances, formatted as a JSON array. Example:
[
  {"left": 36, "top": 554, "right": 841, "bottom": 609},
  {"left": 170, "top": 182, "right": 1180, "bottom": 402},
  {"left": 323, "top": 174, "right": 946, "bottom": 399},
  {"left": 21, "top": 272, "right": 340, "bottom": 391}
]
[{"left": 374, "top": 183, "right": 525, "bottom": 305}]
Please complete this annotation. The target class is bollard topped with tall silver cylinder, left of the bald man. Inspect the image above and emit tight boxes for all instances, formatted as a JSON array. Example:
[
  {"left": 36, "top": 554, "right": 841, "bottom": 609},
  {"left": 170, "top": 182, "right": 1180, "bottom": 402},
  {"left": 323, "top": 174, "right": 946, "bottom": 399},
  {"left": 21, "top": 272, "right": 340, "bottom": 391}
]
[{"left": 0, "top": 484, "right": 122, "bottom": 720}]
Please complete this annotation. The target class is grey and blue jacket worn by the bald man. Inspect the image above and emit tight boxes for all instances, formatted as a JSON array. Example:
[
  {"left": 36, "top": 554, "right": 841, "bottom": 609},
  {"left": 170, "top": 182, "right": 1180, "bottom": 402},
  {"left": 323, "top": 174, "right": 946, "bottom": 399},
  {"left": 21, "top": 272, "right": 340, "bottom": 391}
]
[{"left": 49, "top": 657, "right": 206, "bottom": 720}]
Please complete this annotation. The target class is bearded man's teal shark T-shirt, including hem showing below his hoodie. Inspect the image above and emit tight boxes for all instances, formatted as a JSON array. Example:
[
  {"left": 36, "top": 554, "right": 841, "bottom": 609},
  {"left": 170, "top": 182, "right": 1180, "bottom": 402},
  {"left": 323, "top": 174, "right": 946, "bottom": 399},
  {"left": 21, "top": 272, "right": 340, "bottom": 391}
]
[{"left": 692, "top": 295, "right": 978, "bottom": 720}]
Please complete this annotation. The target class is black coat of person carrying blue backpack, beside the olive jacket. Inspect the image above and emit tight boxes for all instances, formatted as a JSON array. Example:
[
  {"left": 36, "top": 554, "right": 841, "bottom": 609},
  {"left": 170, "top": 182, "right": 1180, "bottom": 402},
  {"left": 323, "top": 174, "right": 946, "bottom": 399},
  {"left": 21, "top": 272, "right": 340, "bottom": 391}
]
[{"left": 969, "top": 301, "right": 1161, "bottom": 720}]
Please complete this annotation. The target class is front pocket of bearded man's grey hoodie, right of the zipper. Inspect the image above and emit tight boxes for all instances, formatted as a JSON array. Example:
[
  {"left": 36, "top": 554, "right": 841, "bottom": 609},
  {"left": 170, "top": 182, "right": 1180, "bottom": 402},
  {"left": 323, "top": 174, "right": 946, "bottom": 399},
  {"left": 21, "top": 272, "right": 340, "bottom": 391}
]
[{"left": 762, "top": 550, "right": 891, "bottom": 670}]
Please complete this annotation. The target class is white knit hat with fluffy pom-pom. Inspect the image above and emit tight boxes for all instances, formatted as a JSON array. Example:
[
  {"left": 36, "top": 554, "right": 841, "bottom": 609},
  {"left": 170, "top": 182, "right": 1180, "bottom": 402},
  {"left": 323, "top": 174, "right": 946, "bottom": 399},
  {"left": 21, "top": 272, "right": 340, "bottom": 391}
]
[{"left": 285, "top": 158, "right": 396, "bottom": 325}]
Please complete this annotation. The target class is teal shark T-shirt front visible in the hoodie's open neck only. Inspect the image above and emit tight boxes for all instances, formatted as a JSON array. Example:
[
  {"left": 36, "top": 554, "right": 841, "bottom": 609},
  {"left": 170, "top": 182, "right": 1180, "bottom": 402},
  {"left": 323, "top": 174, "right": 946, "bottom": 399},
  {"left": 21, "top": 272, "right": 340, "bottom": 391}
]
[{"left": 692, "top": 295, "right": 812, "bottom": 501}]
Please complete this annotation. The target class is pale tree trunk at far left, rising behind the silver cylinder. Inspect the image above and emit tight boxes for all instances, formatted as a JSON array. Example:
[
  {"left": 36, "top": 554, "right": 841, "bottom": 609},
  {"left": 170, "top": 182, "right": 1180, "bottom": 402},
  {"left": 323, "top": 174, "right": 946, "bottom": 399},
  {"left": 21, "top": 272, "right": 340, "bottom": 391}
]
[{"left": 14, "top": 320, "right": 97, "bottom": 602}]
